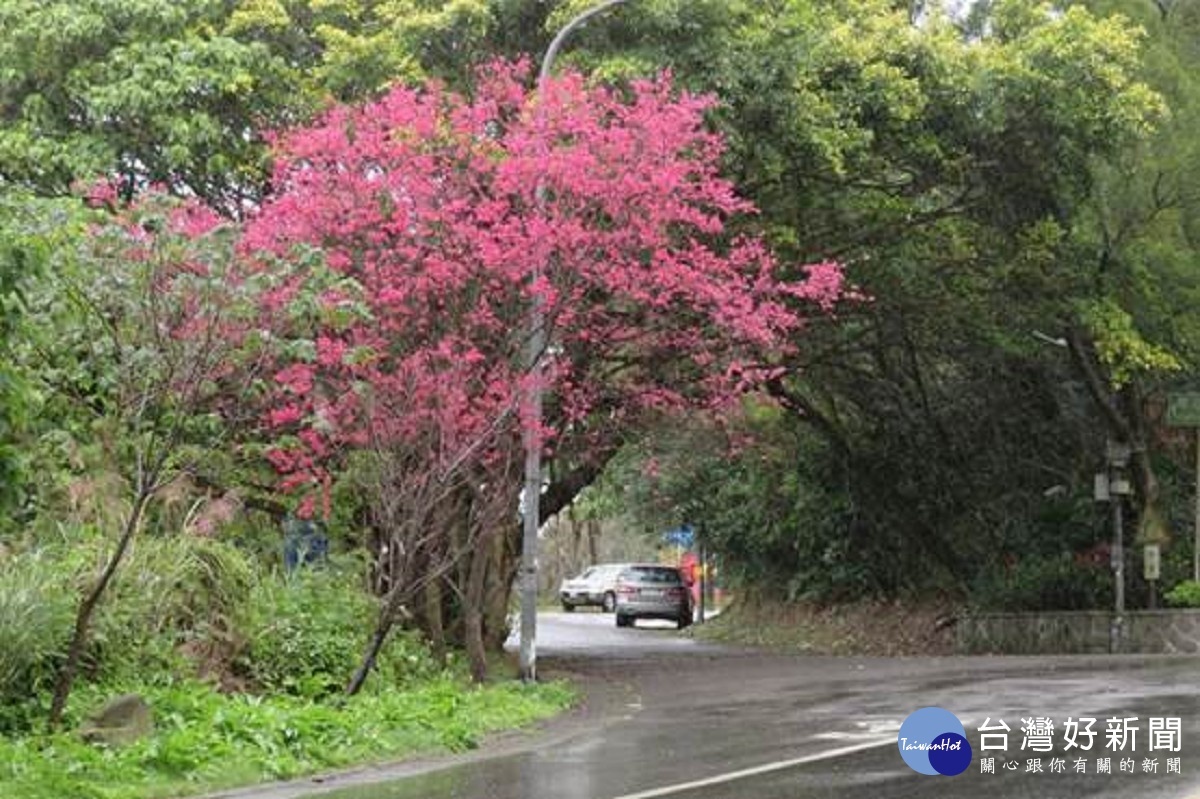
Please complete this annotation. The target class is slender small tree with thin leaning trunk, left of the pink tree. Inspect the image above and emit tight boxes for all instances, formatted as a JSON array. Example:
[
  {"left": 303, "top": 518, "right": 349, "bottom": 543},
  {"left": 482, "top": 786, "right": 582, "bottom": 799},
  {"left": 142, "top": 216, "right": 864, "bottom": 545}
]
[{"left": 13, "top": 188, "right": 266, "bottom": 728}]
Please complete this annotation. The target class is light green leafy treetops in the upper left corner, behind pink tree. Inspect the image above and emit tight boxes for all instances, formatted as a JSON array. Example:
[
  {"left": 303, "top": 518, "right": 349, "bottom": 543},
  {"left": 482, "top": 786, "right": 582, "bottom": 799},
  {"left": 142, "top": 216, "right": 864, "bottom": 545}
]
[{"left": 0, "top": 0, "right": 501, "bottom": 208}]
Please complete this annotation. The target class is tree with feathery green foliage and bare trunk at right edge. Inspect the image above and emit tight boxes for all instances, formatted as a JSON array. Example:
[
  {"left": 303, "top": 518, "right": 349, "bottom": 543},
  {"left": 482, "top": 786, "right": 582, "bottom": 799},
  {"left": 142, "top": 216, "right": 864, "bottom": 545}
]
[{"left": 1058, "top": 2, "right": 1200, "bottom": 554}]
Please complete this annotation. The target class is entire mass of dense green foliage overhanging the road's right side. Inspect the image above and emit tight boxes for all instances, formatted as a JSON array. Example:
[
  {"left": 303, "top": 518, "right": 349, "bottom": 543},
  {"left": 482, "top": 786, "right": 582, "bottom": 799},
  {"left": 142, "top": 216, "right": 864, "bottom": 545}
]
[{"left": 585, "top": 2, "right": 1196, "bottom": 608}]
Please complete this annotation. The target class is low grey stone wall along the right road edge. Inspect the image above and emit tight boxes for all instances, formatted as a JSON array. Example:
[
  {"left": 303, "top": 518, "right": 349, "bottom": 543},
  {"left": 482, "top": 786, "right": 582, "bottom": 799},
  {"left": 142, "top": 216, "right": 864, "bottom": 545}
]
[{"left": 955, "top": 609, "right": 1200, "bottom": 655}]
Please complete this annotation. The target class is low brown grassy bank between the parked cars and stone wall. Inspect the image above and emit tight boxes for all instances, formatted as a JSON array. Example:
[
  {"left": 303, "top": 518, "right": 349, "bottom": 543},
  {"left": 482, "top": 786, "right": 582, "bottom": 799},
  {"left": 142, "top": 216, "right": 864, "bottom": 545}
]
[{"left": 694, "top": 602, "right": 954, "bottom": 656}]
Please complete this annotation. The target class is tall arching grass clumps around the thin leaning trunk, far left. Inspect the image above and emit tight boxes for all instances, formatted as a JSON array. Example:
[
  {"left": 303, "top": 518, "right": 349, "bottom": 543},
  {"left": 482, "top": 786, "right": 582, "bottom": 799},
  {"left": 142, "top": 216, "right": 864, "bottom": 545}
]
[{"left": 0, "top": 525, "right": 253, "bottom": 731}]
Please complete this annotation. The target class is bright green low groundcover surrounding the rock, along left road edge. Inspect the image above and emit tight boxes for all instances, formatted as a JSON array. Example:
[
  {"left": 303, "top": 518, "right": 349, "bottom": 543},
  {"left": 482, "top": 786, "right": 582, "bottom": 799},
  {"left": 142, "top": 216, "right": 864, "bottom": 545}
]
[{"left": 0, "top": 674, "right": 575, "bottom": 799}]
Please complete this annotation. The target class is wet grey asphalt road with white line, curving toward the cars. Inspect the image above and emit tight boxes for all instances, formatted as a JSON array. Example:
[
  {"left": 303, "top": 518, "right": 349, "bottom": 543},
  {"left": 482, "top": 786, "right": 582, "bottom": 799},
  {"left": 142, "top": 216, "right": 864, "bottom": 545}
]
[{"left": 226, "top": 612, "right": 1200, "bottom": 799}]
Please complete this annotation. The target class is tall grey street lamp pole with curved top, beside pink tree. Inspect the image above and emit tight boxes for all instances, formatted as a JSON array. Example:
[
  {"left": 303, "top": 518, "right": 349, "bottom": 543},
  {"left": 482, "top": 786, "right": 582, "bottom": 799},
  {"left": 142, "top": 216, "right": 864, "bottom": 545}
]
[{"left": 520, "top": 0, "right": 626, "bottom": 683}]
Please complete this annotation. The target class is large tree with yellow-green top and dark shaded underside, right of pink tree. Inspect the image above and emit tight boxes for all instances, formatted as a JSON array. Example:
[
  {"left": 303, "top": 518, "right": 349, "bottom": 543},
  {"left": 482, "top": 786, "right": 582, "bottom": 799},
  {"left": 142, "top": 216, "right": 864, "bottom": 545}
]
[{"left": 581, "top": 0, "right": 1163, "bottom": 594}]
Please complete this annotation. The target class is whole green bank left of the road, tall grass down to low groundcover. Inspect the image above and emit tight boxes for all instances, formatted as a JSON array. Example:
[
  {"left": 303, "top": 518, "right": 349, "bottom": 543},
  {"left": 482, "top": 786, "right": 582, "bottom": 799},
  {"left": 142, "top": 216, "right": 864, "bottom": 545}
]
[{"left": 0, "top": 536, "right": 574, "bottom": 799}]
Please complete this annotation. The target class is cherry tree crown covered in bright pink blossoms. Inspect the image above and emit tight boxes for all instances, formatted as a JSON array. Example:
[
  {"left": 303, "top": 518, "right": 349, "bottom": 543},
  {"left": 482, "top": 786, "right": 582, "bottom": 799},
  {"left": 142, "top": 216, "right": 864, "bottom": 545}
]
[{"left": 240, "top": 57, "right": 842, "bottom": 676}]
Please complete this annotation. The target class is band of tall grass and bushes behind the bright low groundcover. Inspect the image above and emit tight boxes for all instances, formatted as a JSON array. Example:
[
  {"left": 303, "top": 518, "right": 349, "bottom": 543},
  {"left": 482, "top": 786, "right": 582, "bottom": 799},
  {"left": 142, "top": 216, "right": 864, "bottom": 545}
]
[{"left": 0, "top": 527, "right": 440, "bottom": 719}]
